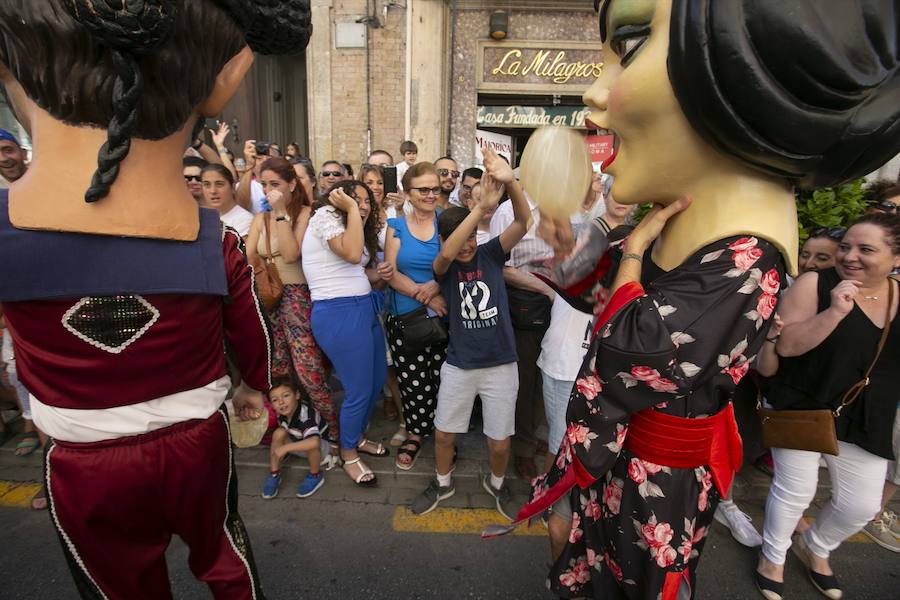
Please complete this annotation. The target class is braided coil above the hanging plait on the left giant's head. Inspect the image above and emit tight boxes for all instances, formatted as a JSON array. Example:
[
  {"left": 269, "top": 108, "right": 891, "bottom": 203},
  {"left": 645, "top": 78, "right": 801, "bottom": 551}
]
[{"left": 65, "top": 0, "right": 175, "bottom": 54}]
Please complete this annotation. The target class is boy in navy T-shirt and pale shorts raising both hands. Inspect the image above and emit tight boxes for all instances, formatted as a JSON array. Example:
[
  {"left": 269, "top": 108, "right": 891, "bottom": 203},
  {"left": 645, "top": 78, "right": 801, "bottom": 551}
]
[{"left": 411, "top": 150, "right": 531, "bottom": 520}]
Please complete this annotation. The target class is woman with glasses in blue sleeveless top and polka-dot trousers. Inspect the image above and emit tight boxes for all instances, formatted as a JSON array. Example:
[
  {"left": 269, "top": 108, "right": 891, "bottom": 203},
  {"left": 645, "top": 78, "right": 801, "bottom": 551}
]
[{"left": 381, "top": 162, "right": 447, "bottom": 471}]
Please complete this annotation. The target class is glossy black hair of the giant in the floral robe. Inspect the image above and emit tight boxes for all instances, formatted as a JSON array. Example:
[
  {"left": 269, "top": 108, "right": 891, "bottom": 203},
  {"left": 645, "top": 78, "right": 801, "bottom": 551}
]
[{"left": 595, "top": 0, "right": 900, "bottom": 188}]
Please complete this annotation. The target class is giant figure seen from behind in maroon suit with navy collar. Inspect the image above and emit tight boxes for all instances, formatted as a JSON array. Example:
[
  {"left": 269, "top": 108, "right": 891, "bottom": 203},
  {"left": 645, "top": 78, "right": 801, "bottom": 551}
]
[{"left": 0, "top": 0, "right": 310, "bottom": 600}]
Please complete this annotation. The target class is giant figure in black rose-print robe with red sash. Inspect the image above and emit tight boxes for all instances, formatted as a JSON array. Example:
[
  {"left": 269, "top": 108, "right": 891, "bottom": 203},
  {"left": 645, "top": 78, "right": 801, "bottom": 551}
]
[{"left": 510, "top": 0, "right": 900, "bottom": 600}]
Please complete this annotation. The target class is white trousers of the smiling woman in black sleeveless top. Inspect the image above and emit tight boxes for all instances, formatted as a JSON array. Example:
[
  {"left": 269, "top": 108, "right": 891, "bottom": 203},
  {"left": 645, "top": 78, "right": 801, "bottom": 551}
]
[{"left": 762, "top": 442, "right": 888, "bottom": 565}]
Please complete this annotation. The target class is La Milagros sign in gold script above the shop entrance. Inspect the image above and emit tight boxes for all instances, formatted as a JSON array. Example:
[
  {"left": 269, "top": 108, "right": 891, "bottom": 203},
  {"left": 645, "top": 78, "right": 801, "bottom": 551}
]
[{"left": 478, "top": 40, "right": 603, "bottom": 95}]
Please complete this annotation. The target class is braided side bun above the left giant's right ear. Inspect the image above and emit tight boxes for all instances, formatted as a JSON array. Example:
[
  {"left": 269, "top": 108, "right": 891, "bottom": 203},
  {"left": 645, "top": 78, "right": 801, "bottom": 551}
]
[{"left": 215, "top": 0, "right": 312, "bottom": 55}]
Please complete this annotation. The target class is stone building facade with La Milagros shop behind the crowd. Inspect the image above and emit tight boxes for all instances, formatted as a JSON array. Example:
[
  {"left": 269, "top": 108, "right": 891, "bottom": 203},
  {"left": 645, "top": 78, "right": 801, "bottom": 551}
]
[{"left": 223, "top": 0, "right": 601, "bottom": 173}]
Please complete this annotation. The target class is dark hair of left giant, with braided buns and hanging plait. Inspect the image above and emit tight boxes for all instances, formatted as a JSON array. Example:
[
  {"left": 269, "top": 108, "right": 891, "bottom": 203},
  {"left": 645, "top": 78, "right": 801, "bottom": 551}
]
[{"left": 0, "top": 0, "right": 311, "bottom": 202}]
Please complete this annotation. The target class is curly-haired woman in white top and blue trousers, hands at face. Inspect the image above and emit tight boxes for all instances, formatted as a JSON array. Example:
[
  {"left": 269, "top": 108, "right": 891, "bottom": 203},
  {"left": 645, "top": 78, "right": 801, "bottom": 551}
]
[{"left": 302, "top": 181, "right": 388, "bottom": 487}]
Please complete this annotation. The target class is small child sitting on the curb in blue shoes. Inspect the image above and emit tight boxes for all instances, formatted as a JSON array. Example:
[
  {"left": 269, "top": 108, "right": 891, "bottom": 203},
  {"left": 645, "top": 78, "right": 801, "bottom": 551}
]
[{"left": 262, "top": 377, "right": 328, "bottom": 500}]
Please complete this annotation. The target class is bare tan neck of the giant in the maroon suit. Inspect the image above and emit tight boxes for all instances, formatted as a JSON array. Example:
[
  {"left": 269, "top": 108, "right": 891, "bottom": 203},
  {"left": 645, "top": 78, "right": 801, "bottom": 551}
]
[{"left": 9, "top": 110, "right": 200, "bottom": 241}]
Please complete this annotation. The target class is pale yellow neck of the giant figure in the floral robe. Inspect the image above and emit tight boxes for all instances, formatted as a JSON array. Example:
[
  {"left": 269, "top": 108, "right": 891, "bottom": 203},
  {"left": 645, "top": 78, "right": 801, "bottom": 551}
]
[{"left": 652, "top": 169, "right": 798, "bottom": 275}]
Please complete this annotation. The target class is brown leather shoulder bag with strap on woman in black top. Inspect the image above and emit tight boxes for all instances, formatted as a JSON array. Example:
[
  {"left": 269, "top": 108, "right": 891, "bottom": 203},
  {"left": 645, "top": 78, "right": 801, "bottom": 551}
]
[{"left": 756, "top": 282, "right": 894, "bottom": 456}]
